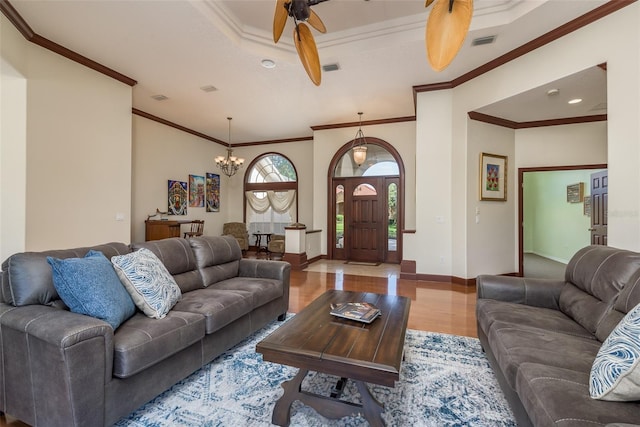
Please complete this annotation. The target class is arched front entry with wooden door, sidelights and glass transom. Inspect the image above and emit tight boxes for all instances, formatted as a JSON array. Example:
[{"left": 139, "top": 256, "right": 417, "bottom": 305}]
[{"left": 327, "top": 137, "right": 404, "bottom": 263}]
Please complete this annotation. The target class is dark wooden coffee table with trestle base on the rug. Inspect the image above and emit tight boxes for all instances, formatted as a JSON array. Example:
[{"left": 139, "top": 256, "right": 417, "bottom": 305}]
[{"left": 256, "top": 290, "right": 411, "bottom": 426}]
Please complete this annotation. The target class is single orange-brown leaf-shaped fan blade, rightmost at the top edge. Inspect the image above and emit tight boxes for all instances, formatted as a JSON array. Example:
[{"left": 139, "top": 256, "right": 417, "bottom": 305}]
[{"left": 426, "top": 0, "right": 473, "bottom": 71}]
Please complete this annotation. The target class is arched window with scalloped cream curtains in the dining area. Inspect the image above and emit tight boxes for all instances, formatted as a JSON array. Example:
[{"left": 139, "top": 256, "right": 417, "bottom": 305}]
[{"left": 245, "top": 153, "right": 298, "bottom": 244}]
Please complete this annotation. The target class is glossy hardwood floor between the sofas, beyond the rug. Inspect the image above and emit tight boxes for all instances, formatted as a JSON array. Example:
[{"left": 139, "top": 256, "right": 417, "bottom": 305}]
[{"left": 0, "top": 261, "right": 478, "bottom": 427}]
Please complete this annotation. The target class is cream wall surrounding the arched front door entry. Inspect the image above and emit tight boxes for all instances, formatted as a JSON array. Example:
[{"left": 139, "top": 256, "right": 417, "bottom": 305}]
[{"left": 307, "top": 122, "right": 416, "bottom": 260}]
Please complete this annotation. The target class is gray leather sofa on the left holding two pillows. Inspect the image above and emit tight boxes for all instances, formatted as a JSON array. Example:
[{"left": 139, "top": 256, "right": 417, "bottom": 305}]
[{"left": 0, "top": 236, "right": 290, "bottom": 427}]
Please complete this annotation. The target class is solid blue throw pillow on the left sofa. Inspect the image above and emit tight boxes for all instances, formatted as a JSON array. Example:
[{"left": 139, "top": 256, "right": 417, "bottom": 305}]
[{"left": 47, "top": 250, "right": 136, "bottom": 331}]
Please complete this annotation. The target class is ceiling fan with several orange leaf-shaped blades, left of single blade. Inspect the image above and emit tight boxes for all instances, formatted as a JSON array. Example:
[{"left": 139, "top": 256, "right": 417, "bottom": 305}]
[{"left": 273, "top": 0, "right": 327, "bottom": 86}]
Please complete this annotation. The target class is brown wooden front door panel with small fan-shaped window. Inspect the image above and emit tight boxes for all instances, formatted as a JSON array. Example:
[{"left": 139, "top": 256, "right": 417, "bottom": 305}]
[{"left": 345, "top": 177, "right": 386, "bottom": 262}]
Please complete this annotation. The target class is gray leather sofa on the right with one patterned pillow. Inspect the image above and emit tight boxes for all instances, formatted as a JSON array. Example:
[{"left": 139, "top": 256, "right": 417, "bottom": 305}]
[{"left": 476, "top": 246, "right": 640, "bottom": 427}]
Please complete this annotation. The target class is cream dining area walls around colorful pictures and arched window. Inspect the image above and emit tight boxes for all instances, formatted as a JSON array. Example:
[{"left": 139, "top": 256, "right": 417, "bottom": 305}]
[{"left": 131, "top": 116, "right": 313, "bottom": 241}]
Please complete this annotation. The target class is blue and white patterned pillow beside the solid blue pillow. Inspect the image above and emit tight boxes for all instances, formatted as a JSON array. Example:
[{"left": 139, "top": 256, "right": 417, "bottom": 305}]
[{"left": 111, "top": 248, "right": 182, "bottom": 319}]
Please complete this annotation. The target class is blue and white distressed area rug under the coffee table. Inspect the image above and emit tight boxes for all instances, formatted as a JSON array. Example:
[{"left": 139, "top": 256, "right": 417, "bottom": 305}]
[{"left": 116, "top": 322, "right": 516, "bottom": 427}]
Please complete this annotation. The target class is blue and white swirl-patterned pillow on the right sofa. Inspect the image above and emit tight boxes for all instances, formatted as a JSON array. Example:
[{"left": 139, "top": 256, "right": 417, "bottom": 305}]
[{"left": 589, "top": 304, "right": 640, "bottom": 402}]
